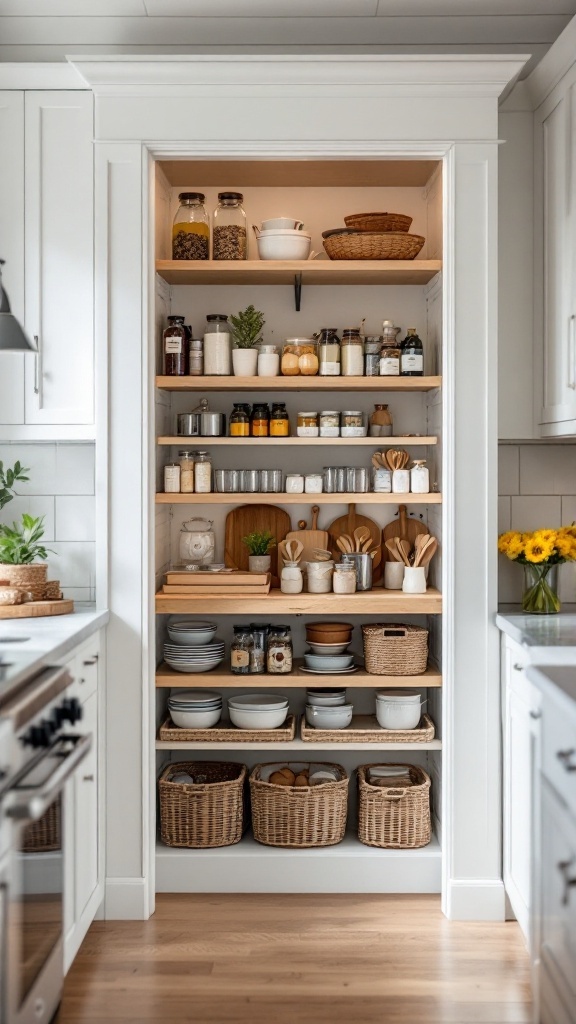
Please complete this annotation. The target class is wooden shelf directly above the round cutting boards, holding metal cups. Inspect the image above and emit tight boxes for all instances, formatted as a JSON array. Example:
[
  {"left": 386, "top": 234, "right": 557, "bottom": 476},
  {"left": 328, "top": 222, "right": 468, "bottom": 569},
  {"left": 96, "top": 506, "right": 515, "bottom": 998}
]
[{"left": 156, "top": 490, "right": 442, "bottom": 505}]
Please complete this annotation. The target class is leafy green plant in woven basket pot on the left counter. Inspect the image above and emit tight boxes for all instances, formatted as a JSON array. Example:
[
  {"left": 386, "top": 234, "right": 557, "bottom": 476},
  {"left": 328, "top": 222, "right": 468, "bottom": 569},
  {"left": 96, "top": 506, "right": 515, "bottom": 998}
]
[{"left": 0, "top": 512, "right": 48, "bottom": 601}]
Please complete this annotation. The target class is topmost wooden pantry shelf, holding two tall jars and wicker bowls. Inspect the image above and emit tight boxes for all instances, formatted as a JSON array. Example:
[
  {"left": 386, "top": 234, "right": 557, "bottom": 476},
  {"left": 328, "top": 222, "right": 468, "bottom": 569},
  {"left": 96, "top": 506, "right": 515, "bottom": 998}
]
[{"left": 156, "top": 259, "right": 442, "bottom": 285}]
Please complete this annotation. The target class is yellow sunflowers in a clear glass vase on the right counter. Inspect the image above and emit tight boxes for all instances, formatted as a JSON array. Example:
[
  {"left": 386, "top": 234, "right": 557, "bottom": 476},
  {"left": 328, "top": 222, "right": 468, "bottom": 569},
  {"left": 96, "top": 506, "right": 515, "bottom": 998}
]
[{"left": 498, "top": 523, "right": 576, "bottom": 615}]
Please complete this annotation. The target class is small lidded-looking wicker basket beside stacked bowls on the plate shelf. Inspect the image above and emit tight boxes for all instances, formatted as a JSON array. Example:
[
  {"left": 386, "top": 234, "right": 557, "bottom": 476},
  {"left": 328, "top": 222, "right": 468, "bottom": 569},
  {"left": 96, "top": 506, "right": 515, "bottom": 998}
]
[{"left": 362, "top": 623, "right": 428, "bottom": 676}]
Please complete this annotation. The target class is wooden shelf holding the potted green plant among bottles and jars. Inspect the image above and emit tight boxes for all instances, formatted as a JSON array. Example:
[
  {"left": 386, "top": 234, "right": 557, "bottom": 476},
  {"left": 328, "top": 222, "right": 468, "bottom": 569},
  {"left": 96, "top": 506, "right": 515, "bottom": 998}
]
[{"left": 156, "top": 374, "right": 442, "bottom": 391}]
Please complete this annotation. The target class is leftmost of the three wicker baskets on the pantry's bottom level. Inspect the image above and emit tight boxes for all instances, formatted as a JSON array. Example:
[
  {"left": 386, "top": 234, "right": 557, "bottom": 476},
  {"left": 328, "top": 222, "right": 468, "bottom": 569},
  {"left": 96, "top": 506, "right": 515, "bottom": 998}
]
[{"left": 158, "top": 761, "right": 248, "bottom": 850}]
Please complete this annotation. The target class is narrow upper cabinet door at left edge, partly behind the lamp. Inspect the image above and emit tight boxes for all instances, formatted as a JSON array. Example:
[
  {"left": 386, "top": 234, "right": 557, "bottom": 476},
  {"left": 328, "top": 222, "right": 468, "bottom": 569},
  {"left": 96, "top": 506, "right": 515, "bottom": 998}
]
[{"left": 0, "top": 91, "right": 25, "bottom": 425}]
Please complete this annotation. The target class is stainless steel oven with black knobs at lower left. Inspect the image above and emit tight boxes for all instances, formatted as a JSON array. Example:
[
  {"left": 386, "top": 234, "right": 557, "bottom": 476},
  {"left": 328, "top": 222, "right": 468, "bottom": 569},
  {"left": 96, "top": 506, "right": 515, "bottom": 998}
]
[{"left": 0, "top": 669, "right": 92, "bottom": 1024}]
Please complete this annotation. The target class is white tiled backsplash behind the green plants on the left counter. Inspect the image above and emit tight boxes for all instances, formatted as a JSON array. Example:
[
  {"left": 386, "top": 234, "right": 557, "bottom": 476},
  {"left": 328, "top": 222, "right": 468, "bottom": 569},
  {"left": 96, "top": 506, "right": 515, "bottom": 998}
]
[{"left": 0, "top": 441, "right": 95, "bottom": 601}]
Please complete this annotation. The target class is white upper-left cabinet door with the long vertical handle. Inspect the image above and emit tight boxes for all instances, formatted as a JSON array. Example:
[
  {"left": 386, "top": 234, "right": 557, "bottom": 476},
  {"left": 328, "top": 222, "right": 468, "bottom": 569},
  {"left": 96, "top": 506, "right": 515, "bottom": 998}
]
[{"left": 25, "top": 91, "right": 93, "bottom": 425}]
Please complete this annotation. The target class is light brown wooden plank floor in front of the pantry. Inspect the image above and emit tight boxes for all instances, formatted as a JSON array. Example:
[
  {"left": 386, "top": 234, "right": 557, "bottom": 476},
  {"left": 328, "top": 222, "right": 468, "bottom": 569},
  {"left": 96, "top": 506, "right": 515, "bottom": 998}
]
[{"left": 57, "top": 895, "right": 530, "bottom": 1024}]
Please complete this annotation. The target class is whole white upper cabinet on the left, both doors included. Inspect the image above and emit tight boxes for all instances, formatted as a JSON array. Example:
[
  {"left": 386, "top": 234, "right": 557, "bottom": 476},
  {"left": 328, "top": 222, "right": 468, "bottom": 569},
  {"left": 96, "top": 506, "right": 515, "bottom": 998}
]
[{"left": 0, "top": 90, "right": 94, "bottom": 439}]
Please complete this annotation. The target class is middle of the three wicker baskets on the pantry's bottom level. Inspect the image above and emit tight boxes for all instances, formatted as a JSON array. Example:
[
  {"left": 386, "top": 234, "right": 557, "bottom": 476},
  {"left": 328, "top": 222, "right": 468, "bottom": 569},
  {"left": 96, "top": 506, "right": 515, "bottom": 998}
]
[{"left": 250, "top": 764, "right": 348, "bottom": 850}]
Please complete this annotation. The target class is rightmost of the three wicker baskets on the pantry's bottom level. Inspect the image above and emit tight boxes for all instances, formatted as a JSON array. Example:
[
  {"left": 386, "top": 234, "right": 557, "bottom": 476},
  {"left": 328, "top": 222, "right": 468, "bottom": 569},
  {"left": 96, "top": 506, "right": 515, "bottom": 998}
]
[{"left": 358, "top": 765, "right": 431, "bottom": 850}]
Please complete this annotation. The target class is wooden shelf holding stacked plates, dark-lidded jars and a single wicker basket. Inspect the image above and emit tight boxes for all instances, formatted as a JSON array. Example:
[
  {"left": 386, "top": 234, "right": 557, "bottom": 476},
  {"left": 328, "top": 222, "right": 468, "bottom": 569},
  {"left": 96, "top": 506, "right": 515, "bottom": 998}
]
[{"left": 156, "top": 659, "right": 442, "bottom": 692}]
